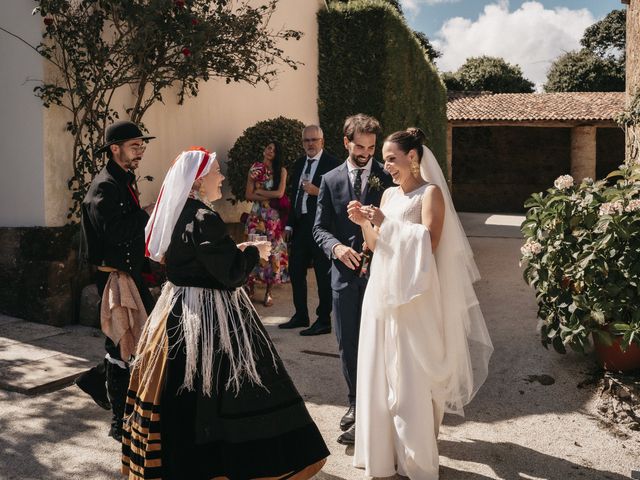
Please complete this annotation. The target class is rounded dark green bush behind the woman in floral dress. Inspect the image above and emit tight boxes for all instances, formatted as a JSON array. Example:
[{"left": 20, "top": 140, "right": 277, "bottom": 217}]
[{"left": 226, "top": 117, "right": 304, "bottom": 205}]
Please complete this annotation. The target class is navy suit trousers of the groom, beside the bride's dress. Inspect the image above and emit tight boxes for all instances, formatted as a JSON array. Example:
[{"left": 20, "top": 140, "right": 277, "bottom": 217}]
[{"left": 333, "top": 277, "right": 367, "bottom": 405}]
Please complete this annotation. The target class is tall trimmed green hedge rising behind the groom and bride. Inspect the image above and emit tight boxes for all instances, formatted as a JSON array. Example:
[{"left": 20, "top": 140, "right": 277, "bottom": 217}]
[{"left": 318, "top": 0, "right": 447, "bottom": 172}]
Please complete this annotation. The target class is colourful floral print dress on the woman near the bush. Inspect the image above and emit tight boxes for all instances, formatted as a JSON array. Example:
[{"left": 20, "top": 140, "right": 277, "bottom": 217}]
[{"left": 245, "top": 162, "right": 289, "bottom": 285}]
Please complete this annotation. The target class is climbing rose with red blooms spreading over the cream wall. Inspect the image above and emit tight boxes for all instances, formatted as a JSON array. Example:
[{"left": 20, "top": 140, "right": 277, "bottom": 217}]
[{"left": 2, "top": 0, "right": 301, "bottom": 220}]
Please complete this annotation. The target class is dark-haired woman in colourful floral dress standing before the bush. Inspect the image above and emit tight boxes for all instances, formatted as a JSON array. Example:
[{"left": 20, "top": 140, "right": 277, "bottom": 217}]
[{"left": 245, "top": 142, "right": 289, "bottom": 307}]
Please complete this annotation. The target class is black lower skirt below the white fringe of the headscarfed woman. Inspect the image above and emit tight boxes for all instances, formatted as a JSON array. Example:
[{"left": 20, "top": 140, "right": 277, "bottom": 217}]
[{"left": 160, "top": 302, "right": 329, "bottom": 480}]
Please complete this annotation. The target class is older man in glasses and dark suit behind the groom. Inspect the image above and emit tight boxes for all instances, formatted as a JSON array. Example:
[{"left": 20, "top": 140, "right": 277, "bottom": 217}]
[{"left": 279, "top": 125, "right": 338, "bottom": 336}]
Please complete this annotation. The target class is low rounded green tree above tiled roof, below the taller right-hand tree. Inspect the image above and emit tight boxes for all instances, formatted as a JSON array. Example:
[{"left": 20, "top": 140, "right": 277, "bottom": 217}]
[{"left": 544, "top": 49, "right": 625, "bottom": 92}]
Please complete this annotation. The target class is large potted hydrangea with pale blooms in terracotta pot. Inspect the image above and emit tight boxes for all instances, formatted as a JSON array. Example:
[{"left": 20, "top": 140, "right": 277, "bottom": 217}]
[{"left": 521, "top": 160, "right": 640, "bottom": 370}]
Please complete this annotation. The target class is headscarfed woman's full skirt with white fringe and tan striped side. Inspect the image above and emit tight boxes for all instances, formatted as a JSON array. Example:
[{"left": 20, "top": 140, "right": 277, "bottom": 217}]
[{"left": 121, "top": 282, "right": 329, "bottom": 480}]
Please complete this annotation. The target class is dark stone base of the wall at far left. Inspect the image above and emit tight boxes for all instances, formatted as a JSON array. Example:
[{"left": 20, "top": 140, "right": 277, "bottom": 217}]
[{"left": 0, "top": 225, "right": 89, "bottom": 326}]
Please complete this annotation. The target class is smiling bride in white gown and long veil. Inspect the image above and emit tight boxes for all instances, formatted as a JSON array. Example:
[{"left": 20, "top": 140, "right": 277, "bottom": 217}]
[{"left": 348, "top": 125, "right": 493, "bottom": 480}]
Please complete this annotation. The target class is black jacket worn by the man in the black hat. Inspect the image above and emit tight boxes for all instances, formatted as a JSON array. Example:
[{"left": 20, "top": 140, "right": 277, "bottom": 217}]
[{"left": 82, "top": 160, "right": 149, "bottom": 275}]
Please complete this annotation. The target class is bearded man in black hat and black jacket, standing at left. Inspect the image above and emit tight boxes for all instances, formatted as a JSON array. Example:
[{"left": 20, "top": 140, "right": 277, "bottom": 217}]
[{"left": 76, "top": 121, "right": 155, "bottom": 441}]
